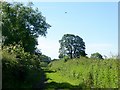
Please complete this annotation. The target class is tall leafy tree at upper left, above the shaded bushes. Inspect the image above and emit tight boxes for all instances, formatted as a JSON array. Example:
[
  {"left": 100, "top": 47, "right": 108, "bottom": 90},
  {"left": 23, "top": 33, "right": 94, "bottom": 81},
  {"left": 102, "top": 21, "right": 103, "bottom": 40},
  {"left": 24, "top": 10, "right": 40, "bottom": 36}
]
[{"left": 0, "top": 2, "right": 50, "bottom": 53}]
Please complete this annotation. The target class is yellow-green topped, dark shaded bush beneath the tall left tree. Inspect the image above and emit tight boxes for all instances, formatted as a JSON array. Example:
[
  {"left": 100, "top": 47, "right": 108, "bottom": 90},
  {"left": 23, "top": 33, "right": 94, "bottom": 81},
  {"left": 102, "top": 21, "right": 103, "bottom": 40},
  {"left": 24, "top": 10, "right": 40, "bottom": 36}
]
[{"left": 2, "top": 45, "right": 42, "bottom": 88}]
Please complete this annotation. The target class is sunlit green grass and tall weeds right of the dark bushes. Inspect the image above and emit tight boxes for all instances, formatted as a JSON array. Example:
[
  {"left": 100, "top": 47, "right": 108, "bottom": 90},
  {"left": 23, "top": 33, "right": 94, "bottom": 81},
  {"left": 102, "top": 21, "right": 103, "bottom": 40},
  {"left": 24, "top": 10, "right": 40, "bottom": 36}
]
[{"left": 46, "top": 58, "right": 119, "bottom": 89}]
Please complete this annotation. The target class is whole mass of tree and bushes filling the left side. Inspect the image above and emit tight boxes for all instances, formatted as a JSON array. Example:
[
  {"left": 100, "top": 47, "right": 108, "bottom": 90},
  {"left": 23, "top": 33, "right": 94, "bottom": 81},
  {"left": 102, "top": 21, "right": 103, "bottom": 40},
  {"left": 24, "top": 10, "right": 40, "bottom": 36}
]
[{"left": 0, "top": 1, "right": 51, "bottom": 88}]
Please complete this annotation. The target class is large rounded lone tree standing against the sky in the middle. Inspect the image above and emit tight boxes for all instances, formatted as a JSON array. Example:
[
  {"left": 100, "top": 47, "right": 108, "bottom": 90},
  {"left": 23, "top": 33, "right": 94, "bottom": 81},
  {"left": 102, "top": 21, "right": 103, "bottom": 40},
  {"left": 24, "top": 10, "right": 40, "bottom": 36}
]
[{"left": 59, "top": 34, "right": 87, "bottom": 59}]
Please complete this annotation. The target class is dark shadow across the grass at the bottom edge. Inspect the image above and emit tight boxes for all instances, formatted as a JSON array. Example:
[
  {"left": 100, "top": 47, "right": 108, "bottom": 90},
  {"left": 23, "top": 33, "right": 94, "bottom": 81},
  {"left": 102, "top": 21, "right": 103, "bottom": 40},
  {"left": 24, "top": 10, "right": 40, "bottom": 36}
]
[{"left": 45, "top": 82, "right": 85, "bottom": 90}]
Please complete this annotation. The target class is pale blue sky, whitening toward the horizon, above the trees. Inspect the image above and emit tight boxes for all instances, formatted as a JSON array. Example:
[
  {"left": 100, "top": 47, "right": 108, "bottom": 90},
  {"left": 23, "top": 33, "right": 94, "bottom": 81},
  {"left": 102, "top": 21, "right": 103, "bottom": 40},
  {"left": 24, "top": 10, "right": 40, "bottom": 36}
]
[{"left": 31, "top": 2, "right": 118, "bottom": 59}]
